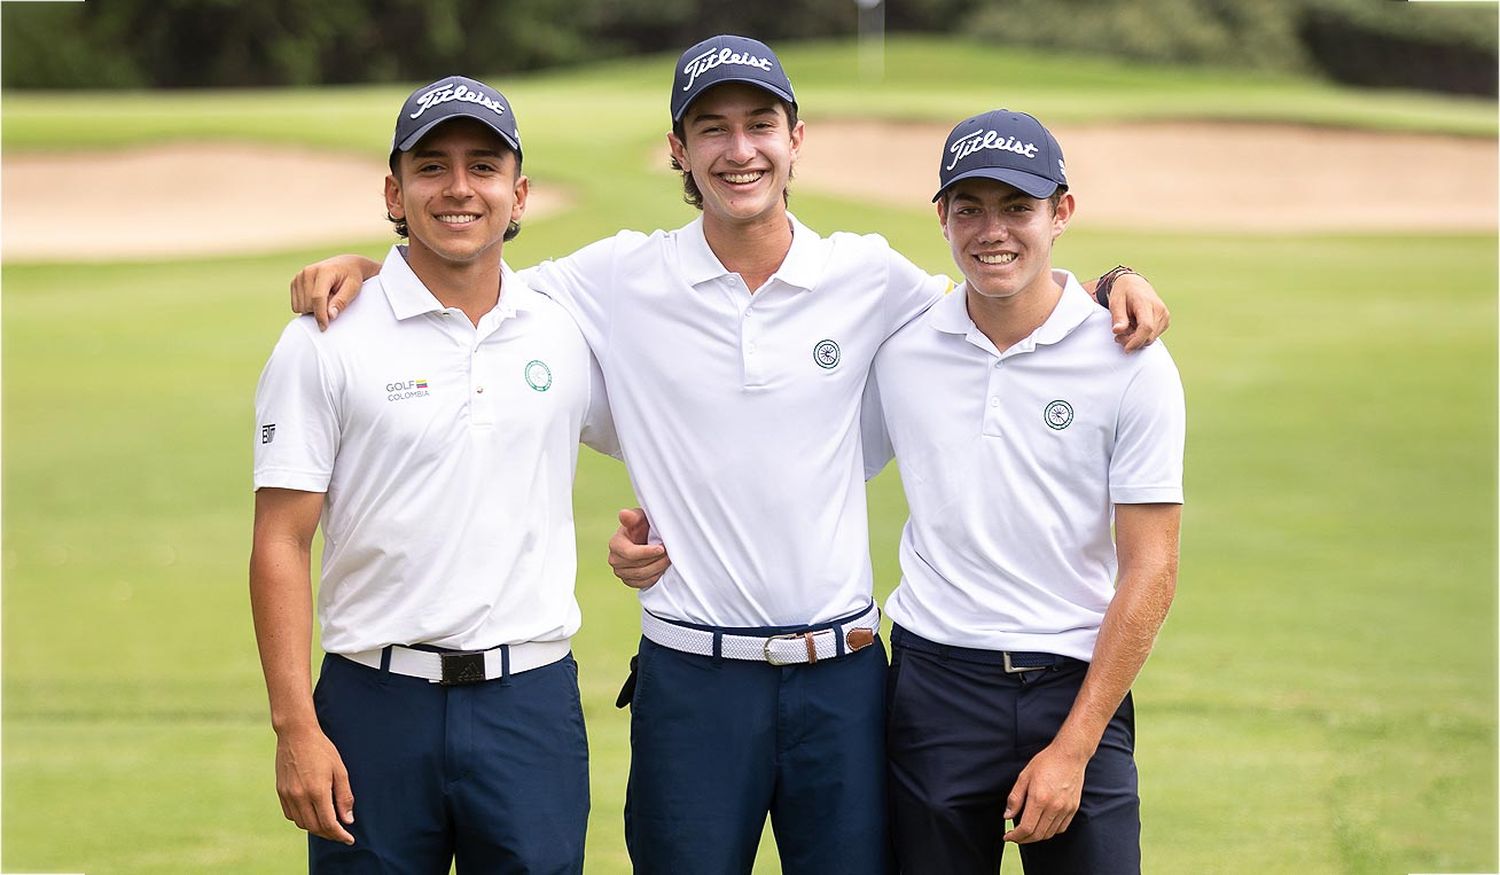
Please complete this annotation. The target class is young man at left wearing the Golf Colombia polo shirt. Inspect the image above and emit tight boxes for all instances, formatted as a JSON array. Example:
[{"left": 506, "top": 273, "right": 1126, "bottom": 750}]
[{"left": 251, "top": 77, "right": 615, "bottom": 875}]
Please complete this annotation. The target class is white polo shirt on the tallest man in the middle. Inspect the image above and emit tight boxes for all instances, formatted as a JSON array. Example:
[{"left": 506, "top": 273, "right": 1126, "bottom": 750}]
[{"left": 527, "top": 218, "right": 951, "bottom": 627}]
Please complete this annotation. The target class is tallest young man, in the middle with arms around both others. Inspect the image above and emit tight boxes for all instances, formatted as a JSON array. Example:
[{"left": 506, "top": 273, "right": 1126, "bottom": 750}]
[{"left": 283, "top": 36, "right": 1166, "bottom": 875}]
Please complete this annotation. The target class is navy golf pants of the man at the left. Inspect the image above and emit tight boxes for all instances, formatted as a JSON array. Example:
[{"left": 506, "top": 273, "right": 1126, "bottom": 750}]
[{"left": 309, "top": 654, "right": 588, "bottom": 875}]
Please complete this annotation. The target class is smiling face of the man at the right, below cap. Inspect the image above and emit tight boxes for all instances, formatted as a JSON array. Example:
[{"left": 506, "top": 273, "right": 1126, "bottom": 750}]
[{"left": 938, "top": 179, "right": 1073, "bottom": 300}]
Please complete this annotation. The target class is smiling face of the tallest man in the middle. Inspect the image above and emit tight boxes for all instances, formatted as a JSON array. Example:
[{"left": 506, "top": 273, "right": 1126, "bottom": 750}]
[{"left": 668, "top": 83, "right": 803, "bottom": 232}]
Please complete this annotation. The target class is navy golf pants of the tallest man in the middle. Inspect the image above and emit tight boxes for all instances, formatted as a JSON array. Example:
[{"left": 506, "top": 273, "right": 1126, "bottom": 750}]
[{"left": 626, "top": 615, "right": 888, "bottom": 875}]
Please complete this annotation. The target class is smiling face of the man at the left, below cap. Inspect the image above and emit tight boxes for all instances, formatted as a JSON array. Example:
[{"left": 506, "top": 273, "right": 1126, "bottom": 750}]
[{"left": 386, "top": 119, "right": 530, "bottom": 276}]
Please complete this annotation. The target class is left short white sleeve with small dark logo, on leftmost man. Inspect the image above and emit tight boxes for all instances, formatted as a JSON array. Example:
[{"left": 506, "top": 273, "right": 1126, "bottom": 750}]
[{"left": 255, "top": 317, "right": 339, "bottom": 492}]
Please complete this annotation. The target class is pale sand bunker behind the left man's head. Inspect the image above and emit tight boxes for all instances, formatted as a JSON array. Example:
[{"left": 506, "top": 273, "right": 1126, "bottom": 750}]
[{"left": 0, "top": 144, "right": 566, "bottom": 261}]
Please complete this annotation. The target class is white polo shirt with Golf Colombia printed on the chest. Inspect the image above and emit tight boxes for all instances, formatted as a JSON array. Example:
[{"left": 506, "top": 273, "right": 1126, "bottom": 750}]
[{"left": 255, "top": 246, "right": 615, "bottom": 653}]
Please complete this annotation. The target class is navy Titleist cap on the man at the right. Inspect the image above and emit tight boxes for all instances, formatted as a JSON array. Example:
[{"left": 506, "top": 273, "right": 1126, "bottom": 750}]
[{"left": 933, "top": 110, "right": 1068, "bottom": 203}]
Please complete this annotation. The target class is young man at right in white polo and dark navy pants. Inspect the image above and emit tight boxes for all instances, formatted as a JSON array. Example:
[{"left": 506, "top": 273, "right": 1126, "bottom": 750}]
[{"left": 864, "top": 110, "right": 1184, "bottom": 875}]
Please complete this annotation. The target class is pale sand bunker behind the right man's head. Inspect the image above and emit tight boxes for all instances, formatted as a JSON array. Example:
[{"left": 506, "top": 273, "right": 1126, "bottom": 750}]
[{"left": 795, "top": 122, "right": 1497, "bottom": 233}]
